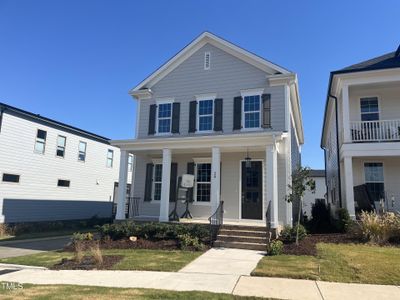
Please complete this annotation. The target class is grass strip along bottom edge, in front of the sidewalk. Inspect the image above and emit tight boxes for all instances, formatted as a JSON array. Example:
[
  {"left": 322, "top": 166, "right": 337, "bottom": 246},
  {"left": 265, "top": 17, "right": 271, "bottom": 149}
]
[{"left": 0, "top": 284, "right": 272, "bottom": 300}]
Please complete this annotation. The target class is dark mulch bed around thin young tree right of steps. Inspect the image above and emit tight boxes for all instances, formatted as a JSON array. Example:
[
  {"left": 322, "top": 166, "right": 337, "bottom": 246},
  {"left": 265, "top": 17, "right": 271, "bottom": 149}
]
[{"left": 283, "top": 233, "right": 359, "bottom": 256}]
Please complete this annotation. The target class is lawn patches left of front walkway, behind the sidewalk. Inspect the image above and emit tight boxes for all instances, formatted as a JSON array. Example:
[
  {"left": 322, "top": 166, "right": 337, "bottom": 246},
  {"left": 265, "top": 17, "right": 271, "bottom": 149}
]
[{"left": 0, "top": 249, "right": 202, "bottom": 272}]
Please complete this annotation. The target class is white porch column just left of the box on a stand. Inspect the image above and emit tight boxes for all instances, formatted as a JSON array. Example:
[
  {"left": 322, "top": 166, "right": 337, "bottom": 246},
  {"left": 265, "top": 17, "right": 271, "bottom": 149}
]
[{"left": 159, "top": 149, "right": 172, "bottom": 222}]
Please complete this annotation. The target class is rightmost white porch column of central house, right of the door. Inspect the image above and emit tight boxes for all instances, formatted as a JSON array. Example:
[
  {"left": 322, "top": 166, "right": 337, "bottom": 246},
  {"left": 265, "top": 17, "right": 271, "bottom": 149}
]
[{"left": 265, "top": 144, "right": 279, "bottom": 228}]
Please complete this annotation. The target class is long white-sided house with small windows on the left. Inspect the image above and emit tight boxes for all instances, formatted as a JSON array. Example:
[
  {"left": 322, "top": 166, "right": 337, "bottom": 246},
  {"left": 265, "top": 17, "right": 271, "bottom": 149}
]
[{"left": 0, "top": 103, "right": 133, "bottom": 223}]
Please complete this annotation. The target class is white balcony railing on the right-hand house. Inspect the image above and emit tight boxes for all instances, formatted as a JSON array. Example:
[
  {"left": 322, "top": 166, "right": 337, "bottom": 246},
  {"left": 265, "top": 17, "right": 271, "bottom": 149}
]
[{"left": 350, "top": 120, "right": 400, "bottom": 143}]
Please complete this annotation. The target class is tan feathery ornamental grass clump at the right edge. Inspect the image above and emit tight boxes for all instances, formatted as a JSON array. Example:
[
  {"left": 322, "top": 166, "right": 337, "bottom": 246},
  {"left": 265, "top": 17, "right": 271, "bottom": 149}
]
[{"left": 360, "top": 211, "right": 400, "bottom": 244}]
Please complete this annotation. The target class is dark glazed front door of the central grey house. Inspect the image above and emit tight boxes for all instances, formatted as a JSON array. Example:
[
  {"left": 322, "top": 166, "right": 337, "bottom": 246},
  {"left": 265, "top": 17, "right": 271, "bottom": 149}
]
[{"left": 241, "top": 161, "right": 263, "bottom": 220}]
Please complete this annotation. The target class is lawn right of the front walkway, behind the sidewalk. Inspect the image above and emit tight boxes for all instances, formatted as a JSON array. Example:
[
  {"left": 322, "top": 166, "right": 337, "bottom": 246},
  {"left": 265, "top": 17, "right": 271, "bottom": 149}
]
[{"left": 252, "top": 243, "right": 400, "bottom": 285}]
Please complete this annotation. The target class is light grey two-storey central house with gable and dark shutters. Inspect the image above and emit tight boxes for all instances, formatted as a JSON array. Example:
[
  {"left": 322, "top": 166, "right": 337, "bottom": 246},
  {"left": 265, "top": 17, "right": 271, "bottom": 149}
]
[{"left": 112, "top": 32, "right": 303, "bottom": 228}]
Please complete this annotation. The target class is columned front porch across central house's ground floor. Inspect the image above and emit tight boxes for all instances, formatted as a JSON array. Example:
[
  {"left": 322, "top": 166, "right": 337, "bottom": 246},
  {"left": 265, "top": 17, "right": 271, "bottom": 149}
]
[{"left": 114, "top": 133, "right": 292, "bottom": 228}]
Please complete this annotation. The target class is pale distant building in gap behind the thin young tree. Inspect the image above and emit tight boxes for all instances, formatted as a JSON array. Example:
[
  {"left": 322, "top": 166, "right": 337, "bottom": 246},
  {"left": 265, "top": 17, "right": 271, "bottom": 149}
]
[{"left": 303, "top": 170, "right": 326, "bottom": 219}]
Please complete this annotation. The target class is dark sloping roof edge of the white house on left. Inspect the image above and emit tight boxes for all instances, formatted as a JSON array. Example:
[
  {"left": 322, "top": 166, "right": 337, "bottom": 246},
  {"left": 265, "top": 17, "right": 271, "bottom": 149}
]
[{"left": 0, "top": 102, "right": 110, "bottom": 144}]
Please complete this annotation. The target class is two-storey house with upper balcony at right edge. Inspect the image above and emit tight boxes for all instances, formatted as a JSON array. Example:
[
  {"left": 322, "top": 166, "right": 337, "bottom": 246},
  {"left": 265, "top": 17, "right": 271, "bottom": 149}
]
[{"left": 321, "top": 47, "right": 400, "bottom": 218}]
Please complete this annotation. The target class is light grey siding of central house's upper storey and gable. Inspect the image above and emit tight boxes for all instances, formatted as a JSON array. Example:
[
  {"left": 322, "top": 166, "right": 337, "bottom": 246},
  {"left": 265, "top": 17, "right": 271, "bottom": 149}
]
[{"left": 138, "top": 44, "right": 285, "bottom": 138}]
